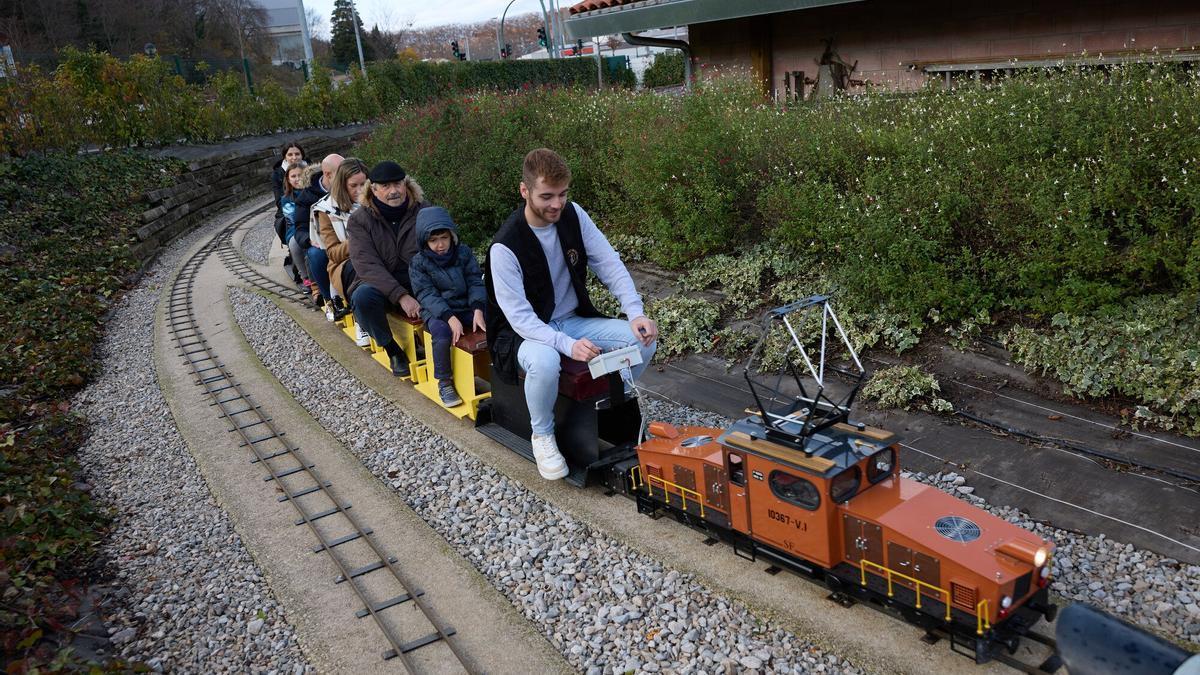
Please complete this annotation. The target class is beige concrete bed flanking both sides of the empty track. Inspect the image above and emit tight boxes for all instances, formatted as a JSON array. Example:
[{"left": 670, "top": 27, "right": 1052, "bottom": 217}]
[{"left": 155, "top": 204, "right": 569, "bottom": 673}]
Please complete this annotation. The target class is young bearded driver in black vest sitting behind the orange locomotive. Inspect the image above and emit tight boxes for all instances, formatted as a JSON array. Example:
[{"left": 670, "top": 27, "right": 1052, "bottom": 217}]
[{"left": 485, "top": 148, "right": 658, "bottom": 480}]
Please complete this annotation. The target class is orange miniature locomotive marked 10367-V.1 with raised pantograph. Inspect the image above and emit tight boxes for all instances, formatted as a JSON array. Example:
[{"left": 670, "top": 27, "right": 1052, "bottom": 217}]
[{"left": 623, "top": 297, "right": 1056, "bottom": 663}]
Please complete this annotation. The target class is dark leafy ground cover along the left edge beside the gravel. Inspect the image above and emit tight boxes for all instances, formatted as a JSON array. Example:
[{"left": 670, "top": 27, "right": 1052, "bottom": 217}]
[{"left": 0, "top": 153, "right": 182, "bottom": 671}]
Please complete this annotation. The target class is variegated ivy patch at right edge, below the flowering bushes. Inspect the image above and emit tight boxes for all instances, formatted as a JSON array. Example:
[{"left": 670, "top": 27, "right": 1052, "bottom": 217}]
[{"left": 1004, "top": 293, "right": 1200, "bottom": 436}]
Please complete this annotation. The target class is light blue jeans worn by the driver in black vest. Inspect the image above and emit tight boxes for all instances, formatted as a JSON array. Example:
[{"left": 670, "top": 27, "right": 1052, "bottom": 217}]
[{"left": 517, "top": 313, "right": 659, "bottom": 436}]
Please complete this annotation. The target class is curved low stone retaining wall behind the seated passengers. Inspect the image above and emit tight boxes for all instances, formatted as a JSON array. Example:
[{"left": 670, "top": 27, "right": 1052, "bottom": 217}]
[{"left": 126, "top": 126, "right": 370, "bottom": 267}]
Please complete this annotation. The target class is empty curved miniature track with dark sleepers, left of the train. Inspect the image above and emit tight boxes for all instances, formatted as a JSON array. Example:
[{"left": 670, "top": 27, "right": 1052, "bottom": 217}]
[{"left": 167, "top": 207, "right": 478, "bottom": 673}]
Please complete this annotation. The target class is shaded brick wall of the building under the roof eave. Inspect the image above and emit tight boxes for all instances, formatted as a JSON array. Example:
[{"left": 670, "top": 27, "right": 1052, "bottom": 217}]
[{"left": 688, "top": 0, "right": 1200, "bottom": 91}]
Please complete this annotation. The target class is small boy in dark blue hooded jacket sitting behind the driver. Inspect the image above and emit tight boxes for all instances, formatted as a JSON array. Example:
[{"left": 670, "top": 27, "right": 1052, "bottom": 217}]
[{"left": 408, "top": 207, "right": 487, "bottom": 407}]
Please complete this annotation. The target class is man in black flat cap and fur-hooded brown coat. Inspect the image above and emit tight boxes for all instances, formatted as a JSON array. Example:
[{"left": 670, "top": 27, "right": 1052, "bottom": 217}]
[{"left": 346, "top": 161, "right": 430, "bottom": 377}]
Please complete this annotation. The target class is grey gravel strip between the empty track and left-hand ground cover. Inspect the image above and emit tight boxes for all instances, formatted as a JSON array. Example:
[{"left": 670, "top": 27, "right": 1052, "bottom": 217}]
[{"left": 74, "top": 208, "right": 311, "bottom": 674}]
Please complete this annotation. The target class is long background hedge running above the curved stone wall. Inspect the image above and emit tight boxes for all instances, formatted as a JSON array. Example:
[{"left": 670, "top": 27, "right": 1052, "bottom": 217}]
[{"left": 0, "top": 48, "right": 628, "bottom": 156}]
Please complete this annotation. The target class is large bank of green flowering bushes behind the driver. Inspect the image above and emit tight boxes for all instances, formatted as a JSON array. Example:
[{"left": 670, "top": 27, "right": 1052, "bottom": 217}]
[{"left": 358, "top": 64, "right": 1200, "bottom": 432}]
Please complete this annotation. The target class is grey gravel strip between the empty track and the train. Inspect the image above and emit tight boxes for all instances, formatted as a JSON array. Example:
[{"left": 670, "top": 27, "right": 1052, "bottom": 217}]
[{"left": 230, "top": 288, "right": 860, "bottom": 675}]
